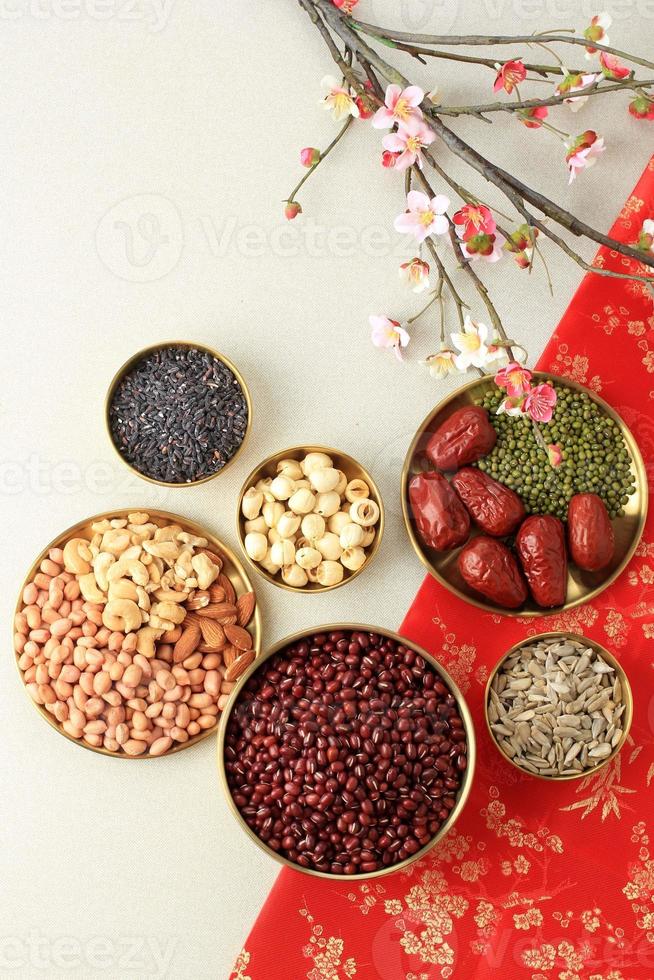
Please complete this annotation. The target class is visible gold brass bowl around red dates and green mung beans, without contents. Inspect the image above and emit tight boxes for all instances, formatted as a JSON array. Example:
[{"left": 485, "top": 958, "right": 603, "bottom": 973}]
[{"left": 401, "top": 371, "right": 648, "bottom": 617}]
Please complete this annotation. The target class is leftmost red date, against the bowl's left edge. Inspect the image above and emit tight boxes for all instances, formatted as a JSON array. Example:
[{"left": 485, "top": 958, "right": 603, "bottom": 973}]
[{"left": 409, "top": 473, "right": 470, "bottom": 551}]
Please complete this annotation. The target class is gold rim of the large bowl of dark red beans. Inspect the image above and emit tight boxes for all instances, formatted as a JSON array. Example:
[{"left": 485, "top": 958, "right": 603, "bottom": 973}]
[{"left": 218, "top": 623, "right": 476, "bottom": 881}]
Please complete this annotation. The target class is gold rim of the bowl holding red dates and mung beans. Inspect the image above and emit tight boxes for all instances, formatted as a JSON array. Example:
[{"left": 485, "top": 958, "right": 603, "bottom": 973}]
[{"left": 400, "top": 371, "right": 649, "bottom": 619}]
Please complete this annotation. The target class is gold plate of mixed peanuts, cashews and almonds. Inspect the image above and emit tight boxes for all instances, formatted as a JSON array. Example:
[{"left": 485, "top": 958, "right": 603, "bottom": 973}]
[{"left": 13, "top": 510, "right": 261, "bottom": 759}]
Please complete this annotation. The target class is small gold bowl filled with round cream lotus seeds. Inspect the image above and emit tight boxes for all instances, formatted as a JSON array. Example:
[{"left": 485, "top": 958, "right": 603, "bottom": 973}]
[{"left": 237, "top": 446, "right": 384, "bottom": 592}]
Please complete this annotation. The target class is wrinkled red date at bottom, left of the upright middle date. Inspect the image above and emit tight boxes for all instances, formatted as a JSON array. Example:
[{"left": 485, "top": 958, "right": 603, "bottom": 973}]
[{"left": 459, "top": 537, "right": 528, "bottom": 609}]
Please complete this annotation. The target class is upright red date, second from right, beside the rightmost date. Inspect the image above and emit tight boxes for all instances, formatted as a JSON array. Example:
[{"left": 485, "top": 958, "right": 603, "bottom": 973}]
[{"left": 516, "top": 514, "right": 568, "bottom": 608}]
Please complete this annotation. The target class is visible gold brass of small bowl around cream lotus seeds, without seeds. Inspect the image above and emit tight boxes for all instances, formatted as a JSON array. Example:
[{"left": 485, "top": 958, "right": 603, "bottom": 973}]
[{"left": 236, "top": 446, "right": 384, "bottom": 594}]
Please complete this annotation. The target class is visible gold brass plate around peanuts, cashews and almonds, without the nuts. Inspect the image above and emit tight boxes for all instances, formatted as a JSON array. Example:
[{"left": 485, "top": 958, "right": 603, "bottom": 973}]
[{"left": 11, "top": 507, "right": 261, "bottom": 762}]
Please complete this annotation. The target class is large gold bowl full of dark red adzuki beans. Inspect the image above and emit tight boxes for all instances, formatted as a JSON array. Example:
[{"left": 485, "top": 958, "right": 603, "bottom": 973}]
[{"left": 218, "top": 623, "right": 475, "bottom": 878}]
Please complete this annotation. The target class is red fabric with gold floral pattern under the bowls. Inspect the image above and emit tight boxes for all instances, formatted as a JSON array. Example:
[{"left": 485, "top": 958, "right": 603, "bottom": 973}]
[{"left": 232, "top": 158, "right": 654, "bottom": 980}]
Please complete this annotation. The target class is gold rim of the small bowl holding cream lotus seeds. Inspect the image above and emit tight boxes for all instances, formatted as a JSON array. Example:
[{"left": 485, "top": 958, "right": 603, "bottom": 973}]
[{"left": 236, "top": 445, "right": 386, "bottom": 595}]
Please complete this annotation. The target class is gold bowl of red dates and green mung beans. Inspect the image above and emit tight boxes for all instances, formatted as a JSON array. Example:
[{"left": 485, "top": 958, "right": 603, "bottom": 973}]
[{"left": 402, "top": 372, "right": 647, "bottom": 616}]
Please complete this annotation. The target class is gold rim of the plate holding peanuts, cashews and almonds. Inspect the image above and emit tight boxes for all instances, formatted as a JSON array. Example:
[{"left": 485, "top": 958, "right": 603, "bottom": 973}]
[{"left": 11, "top": 507, "right": 262, "bottom": 762}]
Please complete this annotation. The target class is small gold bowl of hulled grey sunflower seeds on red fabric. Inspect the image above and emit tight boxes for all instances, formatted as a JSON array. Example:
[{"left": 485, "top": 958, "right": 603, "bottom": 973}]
[{"left": 485, "top": 633, "right": 633, "bottom": 780}]
